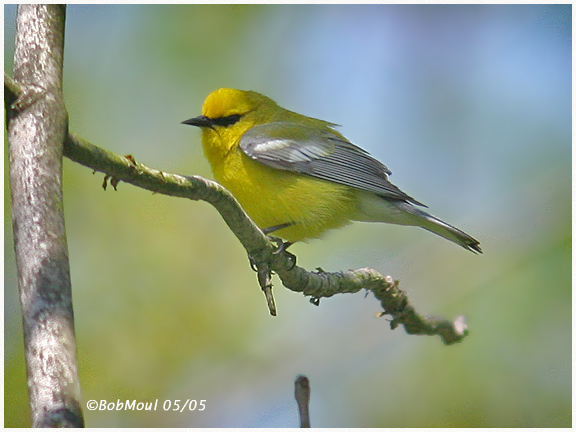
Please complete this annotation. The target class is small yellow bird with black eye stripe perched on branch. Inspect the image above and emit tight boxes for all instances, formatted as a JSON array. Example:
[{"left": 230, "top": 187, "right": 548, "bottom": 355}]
[{"left": 182, "top": 88, "right": 482, "bottom": 253}]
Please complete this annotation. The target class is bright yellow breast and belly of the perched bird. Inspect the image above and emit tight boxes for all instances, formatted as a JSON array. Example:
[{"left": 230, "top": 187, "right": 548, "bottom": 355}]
[{"left": 211, "top": 148, "right": 357, "bottom": 242}]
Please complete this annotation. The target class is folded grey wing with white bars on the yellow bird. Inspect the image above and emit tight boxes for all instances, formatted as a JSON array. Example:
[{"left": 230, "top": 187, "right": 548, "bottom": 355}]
[{"left": 240, "top": 122, "right": 423, "bottom": 205}]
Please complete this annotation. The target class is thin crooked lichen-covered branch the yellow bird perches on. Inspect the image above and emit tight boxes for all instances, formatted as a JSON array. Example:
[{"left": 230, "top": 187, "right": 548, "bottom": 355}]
[{"left": 5, "top": 73, "right": 467, "bottom": 345}]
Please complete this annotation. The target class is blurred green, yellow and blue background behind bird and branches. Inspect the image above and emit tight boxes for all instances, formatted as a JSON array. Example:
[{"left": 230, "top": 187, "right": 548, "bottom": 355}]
[{"left": 4, "top": 5, "right": 572, "bottom": 427}]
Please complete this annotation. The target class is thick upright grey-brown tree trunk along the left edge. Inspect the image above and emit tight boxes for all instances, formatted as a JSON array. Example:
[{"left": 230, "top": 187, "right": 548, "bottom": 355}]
[{"left": 5, "top": 5, "right": 84, "bottom": 427}]
